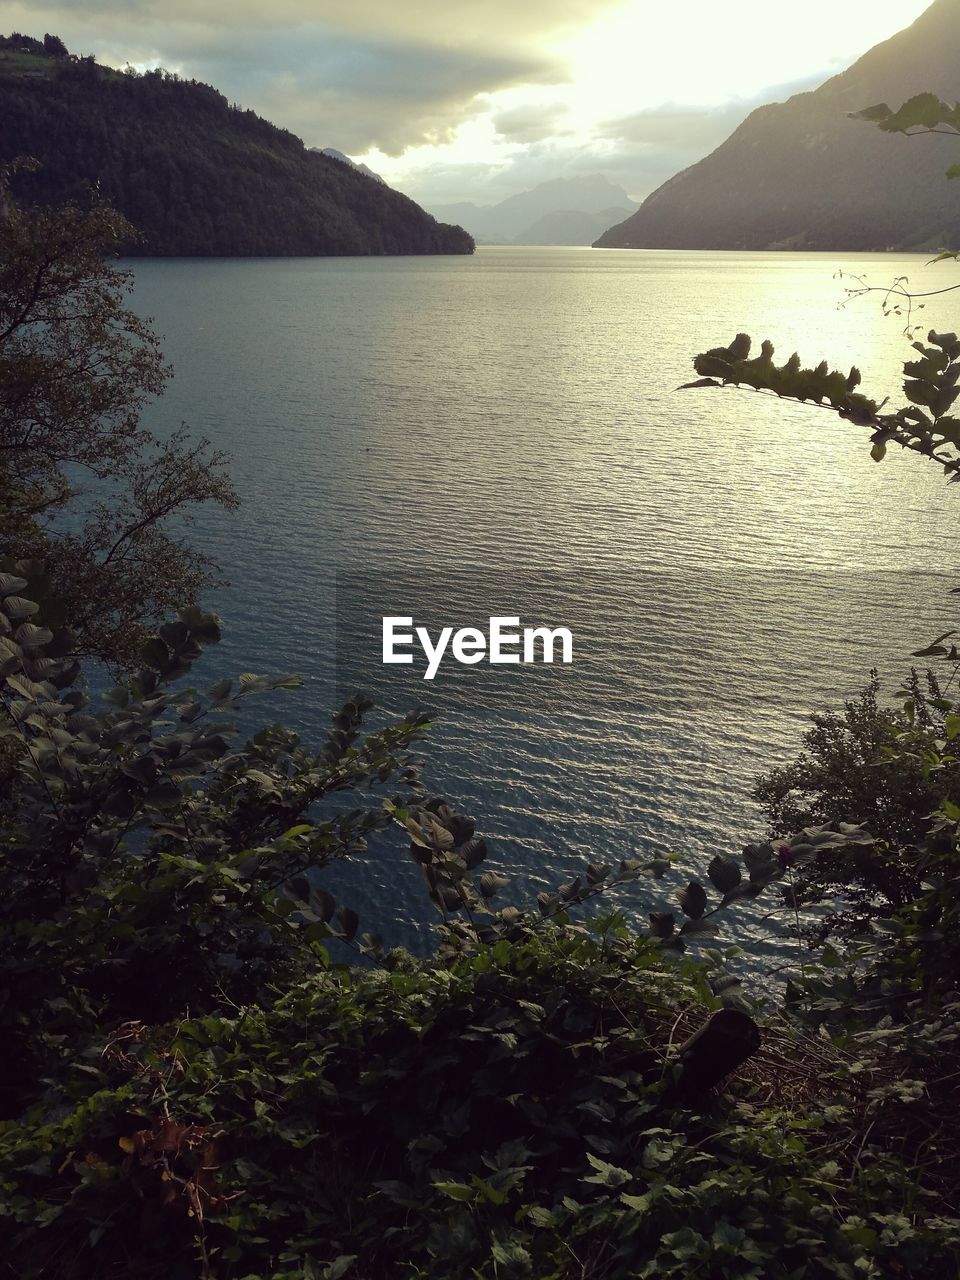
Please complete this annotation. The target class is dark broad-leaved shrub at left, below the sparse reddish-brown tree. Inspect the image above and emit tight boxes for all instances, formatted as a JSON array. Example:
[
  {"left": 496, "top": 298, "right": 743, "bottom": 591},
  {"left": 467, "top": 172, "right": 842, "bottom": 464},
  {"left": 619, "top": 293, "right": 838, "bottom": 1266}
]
[{"left": 0, "top": 563, "right": 425, "bottom": 1116}]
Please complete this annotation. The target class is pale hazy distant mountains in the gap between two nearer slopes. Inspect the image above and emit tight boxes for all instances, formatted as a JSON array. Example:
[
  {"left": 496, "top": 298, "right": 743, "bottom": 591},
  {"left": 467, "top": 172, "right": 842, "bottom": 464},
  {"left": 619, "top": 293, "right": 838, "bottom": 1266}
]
[{"left": 431, "top": 174, "right": 637, "bottom": 244}]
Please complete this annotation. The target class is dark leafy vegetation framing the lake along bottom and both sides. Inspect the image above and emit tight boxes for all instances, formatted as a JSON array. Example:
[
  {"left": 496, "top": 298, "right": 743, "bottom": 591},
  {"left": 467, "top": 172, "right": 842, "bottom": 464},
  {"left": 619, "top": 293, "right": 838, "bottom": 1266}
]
[{"left": 0, "top": 90, "right": 960, "bottom": 1280}]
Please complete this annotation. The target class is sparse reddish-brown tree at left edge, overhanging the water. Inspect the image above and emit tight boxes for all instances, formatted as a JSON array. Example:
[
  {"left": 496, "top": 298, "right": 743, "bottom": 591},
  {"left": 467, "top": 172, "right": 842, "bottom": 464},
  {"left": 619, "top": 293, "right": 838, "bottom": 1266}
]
[{"left": 0, "top": 170, "right": 238, "bottom": 667}]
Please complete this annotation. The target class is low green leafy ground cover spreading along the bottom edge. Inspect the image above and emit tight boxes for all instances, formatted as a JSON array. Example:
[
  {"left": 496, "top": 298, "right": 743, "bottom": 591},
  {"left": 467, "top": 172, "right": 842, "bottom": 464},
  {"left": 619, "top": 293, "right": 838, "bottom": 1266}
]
[{"left": 0, "top": 918, "right": 960, "bottom": 1280}]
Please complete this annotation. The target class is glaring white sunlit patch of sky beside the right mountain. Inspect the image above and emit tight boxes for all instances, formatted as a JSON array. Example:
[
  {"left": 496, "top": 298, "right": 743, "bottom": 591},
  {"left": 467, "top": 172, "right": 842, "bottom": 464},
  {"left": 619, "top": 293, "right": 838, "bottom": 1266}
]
[{"left": 362, "top": 0, "right": 928, "bottom": 195}]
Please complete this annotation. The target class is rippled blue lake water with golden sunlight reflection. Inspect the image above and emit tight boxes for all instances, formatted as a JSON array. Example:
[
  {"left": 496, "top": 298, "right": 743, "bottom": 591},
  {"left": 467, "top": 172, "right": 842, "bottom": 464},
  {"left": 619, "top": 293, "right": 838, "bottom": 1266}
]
[{"left": 128, "top": 247, "right": 960, "bottom": 952}]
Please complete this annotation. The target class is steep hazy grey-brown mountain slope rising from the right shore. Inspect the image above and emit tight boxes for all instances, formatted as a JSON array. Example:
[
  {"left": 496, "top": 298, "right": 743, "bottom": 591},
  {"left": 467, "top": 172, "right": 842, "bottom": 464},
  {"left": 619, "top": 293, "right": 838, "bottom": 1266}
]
[{"left": 596, "top": 0, "right": 960, "bottom": 251}]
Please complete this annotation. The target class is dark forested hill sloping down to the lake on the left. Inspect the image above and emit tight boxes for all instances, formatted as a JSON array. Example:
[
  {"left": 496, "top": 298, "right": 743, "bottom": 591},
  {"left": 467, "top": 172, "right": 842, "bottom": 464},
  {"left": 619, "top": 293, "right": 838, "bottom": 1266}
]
[{"left": 0, "top": 36, "right": 474, "bottom": 256}]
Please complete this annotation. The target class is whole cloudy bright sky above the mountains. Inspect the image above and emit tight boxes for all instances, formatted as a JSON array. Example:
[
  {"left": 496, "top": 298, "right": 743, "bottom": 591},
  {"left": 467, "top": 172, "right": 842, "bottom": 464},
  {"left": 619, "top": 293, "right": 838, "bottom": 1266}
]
[{"left": 0, "top": 0, "right": 929, "bottom": 207}]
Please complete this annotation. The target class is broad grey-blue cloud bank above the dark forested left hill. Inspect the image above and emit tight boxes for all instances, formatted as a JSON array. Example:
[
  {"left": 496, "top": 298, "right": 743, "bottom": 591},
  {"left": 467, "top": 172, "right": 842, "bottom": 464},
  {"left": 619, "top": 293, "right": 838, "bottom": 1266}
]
[{"left": 0, "top": 0, "right": 601, "bottom": 155}]
